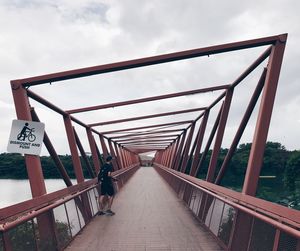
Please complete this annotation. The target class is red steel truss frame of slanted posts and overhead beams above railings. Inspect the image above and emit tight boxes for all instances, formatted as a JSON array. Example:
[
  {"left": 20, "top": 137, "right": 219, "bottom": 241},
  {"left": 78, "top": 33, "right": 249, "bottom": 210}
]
[{"left": 11, "top": 34, "right": 292, "bottom": 251}]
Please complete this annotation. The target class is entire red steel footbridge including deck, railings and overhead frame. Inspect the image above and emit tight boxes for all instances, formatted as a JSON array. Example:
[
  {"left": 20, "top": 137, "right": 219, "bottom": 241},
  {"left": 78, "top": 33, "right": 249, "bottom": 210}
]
[{"left": 0, "top": 34, "right": 300, "bottom": 251}]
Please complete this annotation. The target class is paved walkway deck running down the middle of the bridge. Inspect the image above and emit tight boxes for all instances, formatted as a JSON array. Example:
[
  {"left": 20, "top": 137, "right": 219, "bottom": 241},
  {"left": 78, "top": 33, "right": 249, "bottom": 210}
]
[{"left": 66, "top": 167, "right": 223, "bottom": 251}]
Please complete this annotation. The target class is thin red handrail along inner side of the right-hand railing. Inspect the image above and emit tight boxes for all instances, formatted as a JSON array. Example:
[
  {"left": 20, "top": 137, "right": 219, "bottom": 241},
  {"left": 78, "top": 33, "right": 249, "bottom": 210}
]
[{"left": 154, "top": 163, "right": 300, "bottom": 238}]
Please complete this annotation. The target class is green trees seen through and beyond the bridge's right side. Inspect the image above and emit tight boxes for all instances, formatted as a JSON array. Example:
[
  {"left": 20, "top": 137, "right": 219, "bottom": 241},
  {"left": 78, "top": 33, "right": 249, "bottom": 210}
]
[{"left": 187, "top": 142, "right": 300, "bottom": 210}]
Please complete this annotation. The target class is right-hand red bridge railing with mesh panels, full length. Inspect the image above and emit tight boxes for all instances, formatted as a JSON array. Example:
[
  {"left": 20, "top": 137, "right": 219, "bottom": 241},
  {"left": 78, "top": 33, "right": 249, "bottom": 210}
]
[{"left": 154, "top": 164, "right": 300, "bottom": 251}]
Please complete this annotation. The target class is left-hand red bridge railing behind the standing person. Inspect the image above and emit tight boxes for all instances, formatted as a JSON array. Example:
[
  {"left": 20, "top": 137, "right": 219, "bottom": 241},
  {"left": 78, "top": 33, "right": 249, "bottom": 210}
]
[{"left": 0, "top": 165, "right": 138, "bottom": 251}]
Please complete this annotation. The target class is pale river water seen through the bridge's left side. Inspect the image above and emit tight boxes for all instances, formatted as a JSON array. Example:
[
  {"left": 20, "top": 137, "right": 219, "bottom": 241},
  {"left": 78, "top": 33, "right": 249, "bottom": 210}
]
[{"left": 0, "top": 179, "right": 76, "bottom": 208}]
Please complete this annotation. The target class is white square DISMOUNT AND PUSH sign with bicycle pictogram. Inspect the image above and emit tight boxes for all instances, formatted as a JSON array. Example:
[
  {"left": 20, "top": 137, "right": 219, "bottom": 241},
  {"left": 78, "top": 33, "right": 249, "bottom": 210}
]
[{"left": 7, "top": 120, "right": 45, "bottom": 155}]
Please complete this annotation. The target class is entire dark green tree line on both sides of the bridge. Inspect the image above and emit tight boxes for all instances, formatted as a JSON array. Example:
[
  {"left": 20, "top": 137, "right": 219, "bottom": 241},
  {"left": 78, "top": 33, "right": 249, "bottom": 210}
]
[{"left": 0, "top": 142, "right": 300, "bottom": 209}]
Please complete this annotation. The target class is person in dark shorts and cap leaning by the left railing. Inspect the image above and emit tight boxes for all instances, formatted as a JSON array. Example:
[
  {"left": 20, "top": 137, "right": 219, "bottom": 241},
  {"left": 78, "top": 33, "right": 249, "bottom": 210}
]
[{"left": 98, "top": 156, "right": 117, "bottom": 215}]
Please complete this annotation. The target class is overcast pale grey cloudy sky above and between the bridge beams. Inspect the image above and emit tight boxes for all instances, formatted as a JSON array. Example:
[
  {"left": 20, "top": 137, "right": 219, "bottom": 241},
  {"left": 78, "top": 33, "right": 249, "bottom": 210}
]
[{"left": 0, "top": 0, "right": 300, "bottom": 157}]
